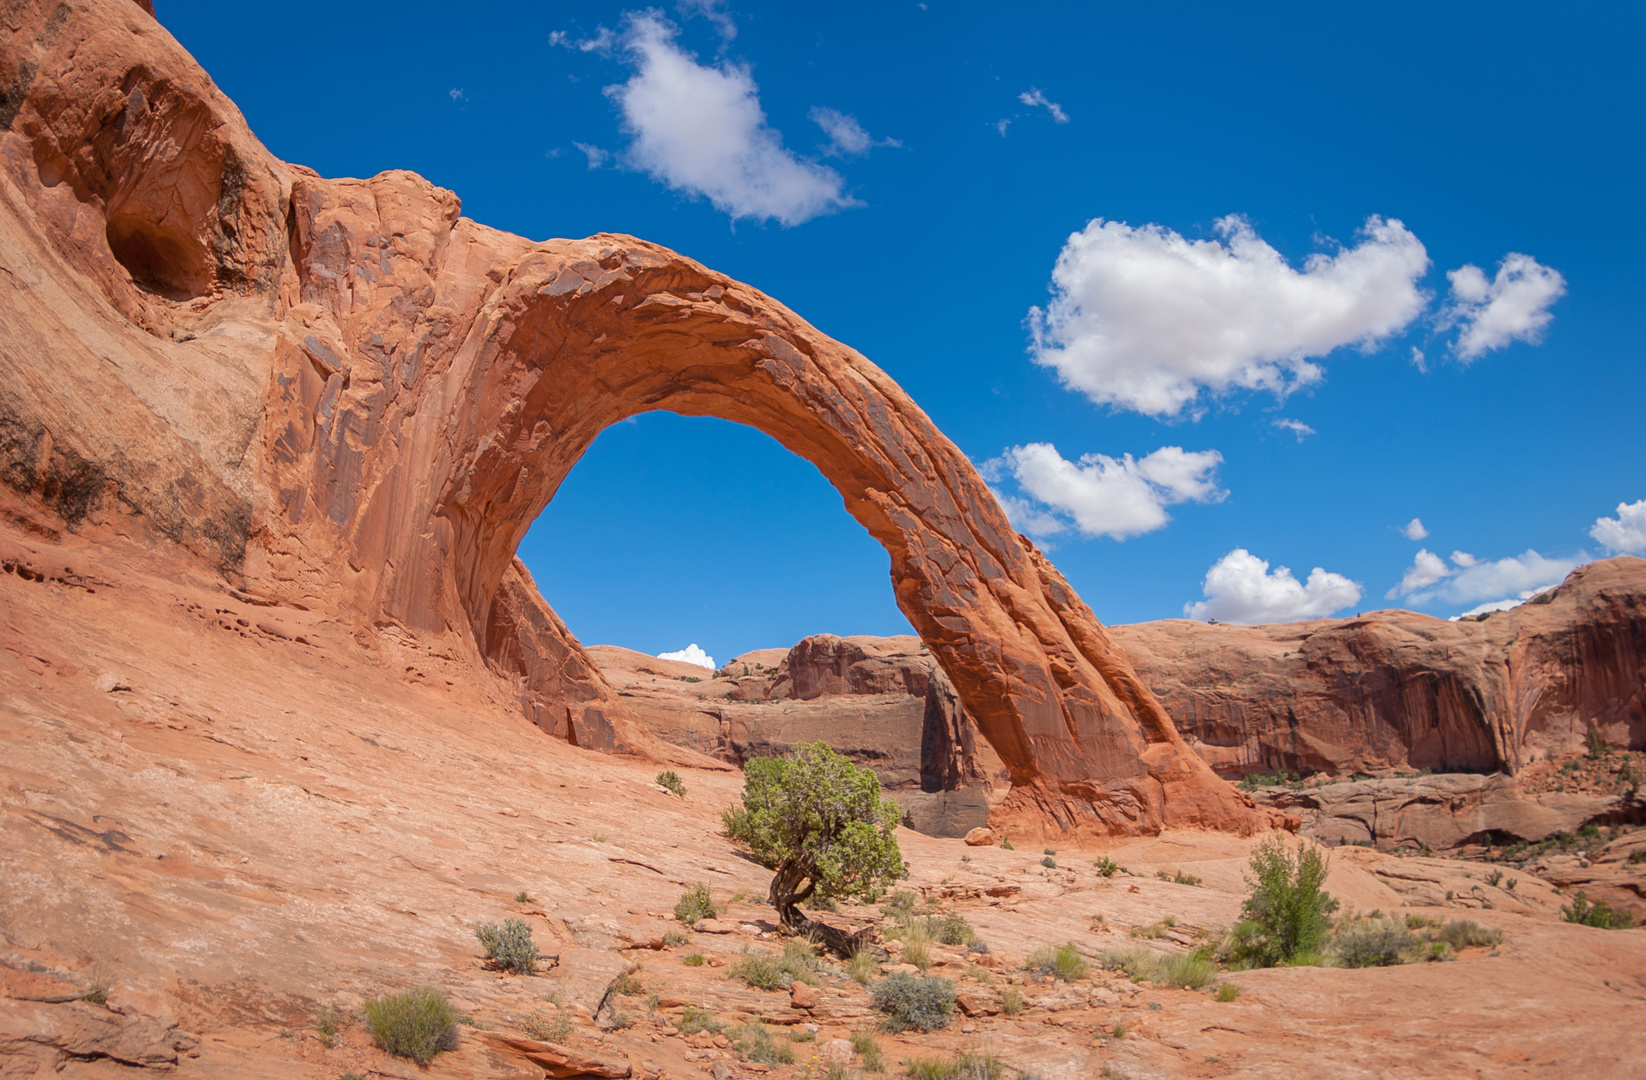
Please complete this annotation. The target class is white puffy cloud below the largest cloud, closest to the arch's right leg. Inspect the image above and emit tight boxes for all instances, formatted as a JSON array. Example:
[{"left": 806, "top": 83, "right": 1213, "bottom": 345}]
[{"left": 981, "top": 443, "right": 1225, "bottom": 540}]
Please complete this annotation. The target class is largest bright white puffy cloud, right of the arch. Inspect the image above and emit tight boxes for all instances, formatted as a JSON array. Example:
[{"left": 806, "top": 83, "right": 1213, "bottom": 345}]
[{"left": 1029, "top": 216, "right": 1429, "bottom": 417}]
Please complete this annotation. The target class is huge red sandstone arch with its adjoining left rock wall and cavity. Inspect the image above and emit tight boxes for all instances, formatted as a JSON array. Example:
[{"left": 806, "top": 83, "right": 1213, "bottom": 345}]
[{"left": 0, "top": 0, "right": 1264, "bottom": 835}]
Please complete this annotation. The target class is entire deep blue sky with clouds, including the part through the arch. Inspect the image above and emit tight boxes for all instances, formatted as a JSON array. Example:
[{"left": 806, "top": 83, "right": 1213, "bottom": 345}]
[{"left": 160, "top": 0, "right": 1646, "bottom": 660}]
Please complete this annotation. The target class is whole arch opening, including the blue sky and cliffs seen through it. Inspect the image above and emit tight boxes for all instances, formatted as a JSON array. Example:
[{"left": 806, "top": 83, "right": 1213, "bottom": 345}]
[{"left": 518, "top": 412, "right": 993, "bottom": 836}]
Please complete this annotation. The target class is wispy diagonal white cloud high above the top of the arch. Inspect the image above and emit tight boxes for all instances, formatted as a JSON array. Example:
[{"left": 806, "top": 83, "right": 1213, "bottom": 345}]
[{"left": 606, "top": 12, "right": 858, "bottom": 226}]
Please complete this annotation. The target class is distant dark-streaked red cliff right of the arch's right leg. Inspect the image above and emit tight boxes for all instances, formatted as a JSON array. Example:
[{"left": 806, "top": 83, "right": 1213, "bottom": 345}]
[{"left": 1111, "top": 556, "right": 1646, "bottom": 777}]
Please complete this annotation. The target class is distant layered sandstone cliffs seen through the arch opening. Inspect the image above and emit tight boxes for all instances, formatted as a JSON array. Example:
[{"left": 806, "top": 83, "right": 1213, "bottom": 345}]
[{"left": 588, "top": 634, "right": 1011, "bottom": 836}]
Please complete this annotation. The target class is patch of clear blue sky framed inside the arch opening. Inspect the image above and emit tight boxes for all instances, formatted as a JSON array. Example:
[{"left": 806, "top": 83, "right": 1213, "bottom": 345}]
[{"left": 518, "top": 412, "right": 914, "bottom": 663}]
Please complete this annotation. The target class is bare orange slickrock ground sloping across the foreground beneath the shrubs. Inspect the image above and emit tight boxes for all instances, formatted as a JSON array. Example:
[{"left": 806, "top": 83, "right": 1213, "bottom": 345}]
[{"left": 0, "top": 526, "right": 1646, "bottom": 1080}]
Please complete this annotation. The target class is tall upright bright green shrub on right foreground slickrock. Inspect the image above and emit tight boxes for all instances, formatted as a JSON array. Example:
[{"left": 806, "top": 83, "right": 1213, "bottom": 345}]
[{"left": 1225, "top": 836, "right": 1338, "bottom": 968}]
